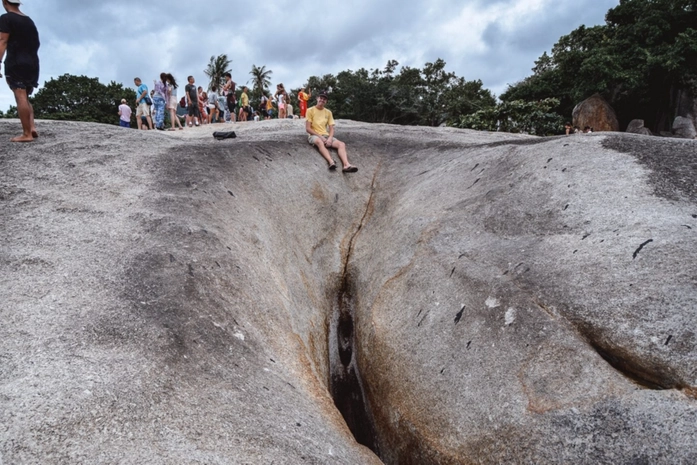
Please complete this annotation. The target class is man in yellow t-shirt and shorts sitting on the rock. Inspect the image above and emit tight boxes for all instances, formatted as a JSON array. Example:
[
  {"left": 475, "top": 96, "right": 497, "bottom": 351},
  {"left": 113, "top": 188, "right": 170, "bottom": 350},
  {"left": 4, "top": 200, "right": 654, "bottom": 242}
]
[{"left": 305, "top": 93, "right": 358, "bottom": 173}]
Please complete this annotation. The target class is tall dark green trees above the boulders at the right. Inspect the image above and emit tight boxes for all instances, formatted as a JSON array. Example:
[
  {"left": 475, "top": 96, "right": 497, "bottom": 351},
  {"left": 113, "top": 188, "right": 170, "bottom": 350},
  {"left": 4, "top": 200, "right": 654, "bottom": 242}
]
[{"left": 500, "top": 0, "right": 697, "bottom": 131}]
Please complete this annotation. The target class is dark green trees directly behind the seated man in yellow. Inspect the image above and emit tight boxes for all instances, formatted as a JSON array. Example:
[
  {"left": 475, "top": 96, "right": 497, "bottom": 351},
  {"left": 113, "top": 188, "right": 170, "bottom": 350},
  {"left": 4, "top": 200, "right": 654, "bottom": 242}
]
[{"left": 307, "top": 59, "right": 495, "bottom": 126}]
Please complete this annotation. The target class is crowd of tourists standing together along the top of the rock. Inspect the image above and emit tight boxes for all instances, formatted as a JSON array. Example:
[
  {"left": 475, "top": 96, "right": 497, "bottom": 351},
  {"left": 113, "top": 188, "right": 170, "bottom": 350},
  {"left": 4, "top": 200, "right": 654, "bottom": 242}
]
[{"left": 118, "top": 73, "right": 312, "bottom": 131}]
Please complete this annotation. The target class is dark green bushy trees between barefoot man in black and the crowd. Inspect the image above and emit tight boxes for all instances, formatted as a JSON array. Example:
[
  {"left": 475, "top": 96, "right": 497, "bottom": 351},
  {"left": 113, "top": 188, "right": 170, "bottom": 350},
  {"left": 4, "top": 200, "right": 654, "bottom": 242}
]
[{"left": 30, "top": 74, "right": 135, "bottom": 125}]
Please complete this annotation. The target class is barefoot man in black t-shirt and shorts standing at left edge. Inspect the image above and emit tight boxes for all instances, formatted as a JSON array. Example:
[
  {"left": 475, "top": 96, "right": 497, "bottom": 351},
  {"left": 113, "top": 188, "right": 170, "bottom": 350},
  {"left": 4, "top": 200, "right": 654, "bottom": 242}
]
[{"left": 0, "top": 0, "right": 41, "bottom": 142}]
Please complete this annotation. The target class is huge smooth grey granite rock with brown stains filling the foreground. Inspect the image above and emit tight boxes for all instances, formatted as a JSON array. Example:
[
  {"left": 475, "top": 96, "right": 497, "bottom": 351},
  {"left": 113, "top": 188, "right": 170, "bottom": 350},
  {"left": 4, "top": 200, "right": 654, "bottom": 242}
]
[{"left": 0, "top": 121, "right": 697, "bottom": 464}]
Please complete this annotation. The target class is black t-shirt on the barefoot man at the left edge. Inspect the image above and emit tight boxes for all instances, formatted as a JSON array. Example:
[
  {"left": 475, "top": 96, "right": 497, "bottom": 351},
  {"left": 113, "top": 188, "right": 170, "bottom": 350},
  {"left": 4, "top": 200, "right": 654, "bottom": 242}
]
[{"left": 0, "top": 13, "right": 40, "bottom": 87}]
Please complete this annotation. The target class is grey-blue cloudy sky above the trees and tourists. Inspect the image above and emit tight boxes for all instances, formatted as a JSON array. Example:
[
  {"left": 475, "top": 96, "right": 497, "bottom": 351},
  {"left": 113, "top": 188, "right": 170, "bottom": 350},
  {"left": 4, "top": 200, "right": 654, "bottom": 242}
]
[{"left": 0, "top": 0, "right": 619, "bottom": 110}]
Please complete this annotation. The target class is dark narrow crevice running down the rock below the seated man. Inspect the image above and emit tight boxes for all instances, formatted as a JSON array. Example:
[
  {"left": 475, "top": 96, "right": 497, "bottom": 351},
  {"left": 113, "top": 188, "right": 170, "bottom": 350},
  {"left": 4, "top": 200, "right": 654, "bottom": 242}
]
[{"left": 327, "top": 168, "right": 380, "bottom": 457}]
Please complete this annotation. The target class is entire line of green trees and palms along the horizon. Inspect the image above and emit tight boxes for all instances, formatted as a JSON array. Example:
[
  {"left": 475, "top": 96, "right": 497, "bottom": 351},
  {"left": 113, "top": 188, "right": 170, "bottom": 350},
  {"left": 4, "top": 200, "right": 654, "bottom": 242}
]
[{"left": 0, "top": 0, "right": 697, "bottom": 135}]
